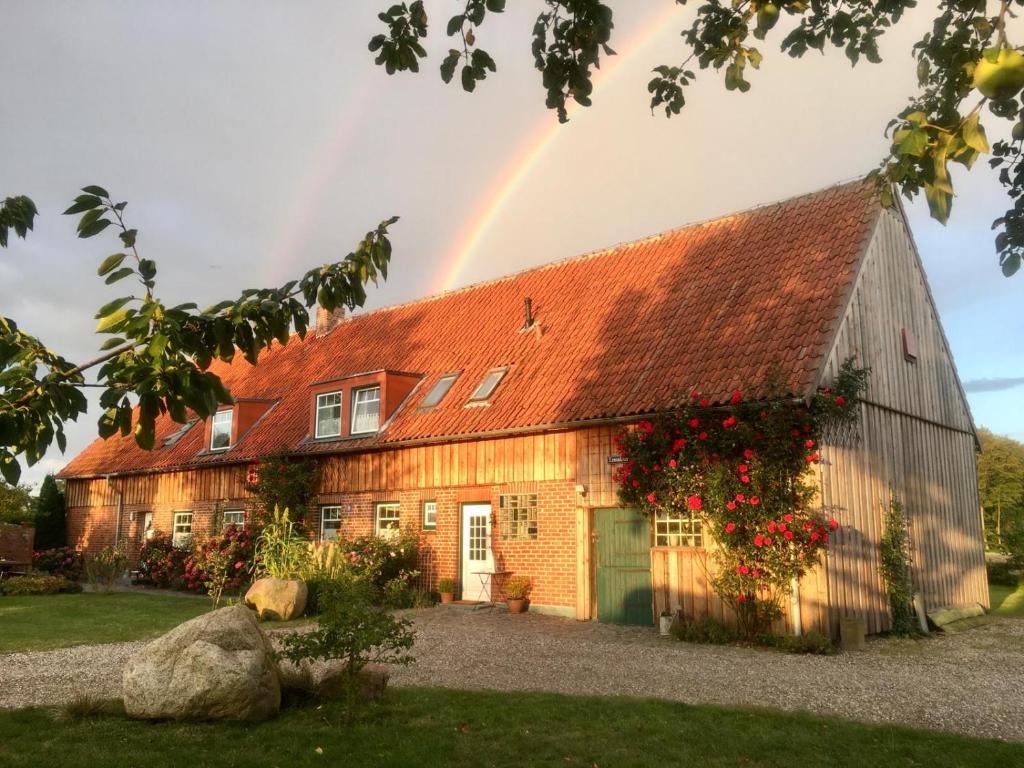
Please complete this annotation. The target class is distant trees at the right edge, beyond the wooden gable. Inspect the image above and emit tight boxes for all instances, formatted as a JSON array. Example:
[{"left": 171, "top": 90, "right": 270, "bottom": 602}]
[{"left": 978, "top": 427, "right": 1024, "bottom": 549}]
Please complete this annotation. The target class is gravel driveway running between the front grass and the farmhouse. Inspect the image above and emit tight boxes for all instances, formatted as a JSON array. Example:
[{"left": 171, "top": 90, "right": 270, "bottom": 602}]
[{"left": 0, "top": 608, "right": 1024, "bottom": 741}]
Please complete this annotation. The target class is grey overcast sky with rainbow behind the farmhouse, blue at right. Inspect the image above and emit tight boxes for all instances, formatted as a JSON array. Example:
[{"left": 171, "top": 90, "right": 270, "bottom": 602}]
[{"left": 0, "top": 0, "right": 1024, "bottom": 489}]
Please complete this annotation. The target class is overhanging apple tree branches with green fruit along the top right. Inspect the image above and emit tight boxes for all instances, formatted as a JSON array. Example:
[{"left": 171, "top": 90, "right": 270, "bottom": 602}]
[{"left": 370, "top": 0, "right": 1024, "bottom": 276}]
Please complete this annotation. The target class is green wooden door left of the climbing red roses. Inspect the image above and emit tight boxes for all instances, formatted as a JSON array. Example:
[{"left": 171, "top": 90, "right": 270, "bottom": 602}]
[{"left": 595, "top": 509, "right": 654, "bottom": 627}]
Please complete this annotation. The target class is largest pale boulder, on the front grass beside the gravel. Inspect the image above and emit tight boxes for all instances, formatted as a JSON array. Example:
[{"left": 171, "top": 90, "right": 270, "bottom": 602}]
[{"left": 122, "top": 605, "right": 281, "bottom": 721}]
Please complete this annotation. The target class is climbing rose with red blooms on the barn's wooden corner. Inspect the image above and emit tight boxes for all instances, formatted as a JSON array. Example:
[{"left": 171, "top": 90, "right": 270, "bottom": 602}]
[{"left": 614, "top": 360, "right": 867, "bottom": 639}]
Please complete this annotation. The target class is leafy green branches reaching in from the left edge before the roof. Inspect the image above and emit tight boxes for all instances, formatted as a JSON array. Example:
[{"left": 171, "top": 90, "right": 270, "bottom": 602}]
[{"left": 0, "top": 185, "right": 397, "bottom": 483}]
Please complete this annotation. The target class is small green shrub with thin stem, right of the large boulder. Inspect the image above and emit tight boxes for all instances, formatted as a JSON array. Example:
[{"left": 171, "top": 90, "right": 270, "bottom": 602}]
[{"left": 281, "top": 578, "right": 415, "bottom": 722}]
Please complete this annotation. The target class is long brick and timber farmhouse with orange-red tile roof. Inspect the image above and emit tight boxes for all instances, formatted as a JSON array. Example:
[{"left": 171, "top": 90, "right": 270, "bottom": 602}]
[{"left": 56, "top": 182, "right": 988, "bottom": 632}]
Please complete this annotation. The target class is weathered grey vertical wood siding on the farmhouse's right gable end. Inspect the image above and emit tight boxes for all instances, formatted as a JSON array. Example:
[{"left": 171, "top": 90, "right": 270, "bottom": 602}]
[{"left": 821, "top": 205, "right": 988, "bottom": 632}]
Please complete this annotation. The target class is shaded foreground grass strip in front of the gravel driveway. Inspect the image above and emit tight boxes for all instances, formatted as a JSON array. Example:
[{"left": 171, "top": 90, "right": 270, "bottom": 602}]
[{"left": 0, "top": 688, "right": 1024, "bottom": 768}]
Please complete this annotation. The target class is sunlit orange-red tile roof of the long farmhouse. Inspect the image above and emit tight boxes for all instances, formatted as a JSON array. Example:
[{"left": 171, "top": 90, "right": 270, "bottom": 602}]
[{"left": 61, "top": 182, "right": 880, "bottom": 477}]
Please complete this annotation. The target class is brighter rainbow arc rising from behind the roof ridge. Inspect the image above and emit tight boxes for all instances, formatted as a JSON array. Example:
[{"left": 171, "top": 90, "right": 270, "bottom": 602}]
[{"left": 431, "top": 5, "right": 681, "bottom": 293}]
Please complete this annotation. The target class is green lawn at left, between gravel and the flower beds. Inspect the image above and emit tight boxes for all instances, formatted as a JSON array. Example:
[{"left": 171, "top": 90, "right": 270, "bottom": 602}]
[{"left": 0, "top": 592, "right": 210, "bottom": 653}]
